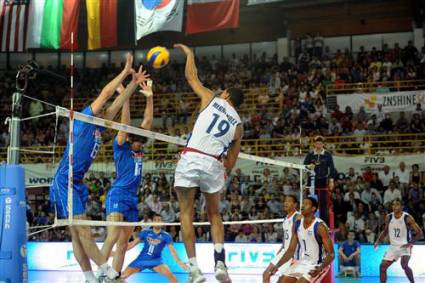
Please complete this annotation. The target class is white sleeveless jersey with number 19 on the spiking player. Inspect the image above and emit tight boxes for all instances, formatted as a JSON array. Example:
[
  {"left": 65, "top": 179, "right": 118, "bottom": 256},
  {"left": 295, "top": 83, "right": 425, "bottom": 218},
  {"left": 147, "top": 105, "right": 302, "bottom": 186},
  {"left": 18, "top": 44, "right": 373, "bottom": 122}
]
[{"left": 186, "top": 97, "right": 241, "bottom": 157}]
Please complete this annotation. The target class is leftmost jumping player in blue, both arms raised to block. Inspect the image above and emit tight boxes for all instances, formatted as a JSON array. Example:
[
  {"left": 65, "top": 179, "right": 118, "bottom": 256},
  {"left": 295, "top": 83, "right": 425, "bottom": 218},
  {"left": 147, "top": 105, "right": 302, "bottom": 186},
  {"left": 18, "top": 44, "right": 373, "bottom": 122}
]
[{"left": 50, "top": 54, "right": 148, "bottom": 283}]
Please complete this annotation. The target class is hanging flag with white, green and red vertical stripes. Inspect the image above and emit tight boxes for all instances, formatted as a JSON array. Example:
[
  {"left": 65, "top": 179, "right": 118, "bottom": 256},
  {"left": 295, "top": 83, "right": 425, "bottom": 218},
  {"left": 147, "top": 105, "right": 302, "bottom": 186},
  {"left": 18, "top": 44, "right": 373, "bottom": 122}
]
[{"left": 27, "top": 0, "right": 80, "bottom": 49}]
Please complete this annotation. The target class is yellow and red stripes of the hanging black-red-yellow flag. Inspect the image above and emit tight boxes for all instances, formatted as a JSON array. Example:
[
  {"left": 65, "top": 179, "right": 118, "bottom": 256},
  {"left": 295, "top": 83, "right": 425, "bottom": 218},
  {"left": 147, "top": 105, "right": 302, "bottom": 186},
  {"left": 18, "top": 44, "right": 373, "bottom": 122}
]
[{"left": 86, "top": 0, "right": 117, "bottom": 50}]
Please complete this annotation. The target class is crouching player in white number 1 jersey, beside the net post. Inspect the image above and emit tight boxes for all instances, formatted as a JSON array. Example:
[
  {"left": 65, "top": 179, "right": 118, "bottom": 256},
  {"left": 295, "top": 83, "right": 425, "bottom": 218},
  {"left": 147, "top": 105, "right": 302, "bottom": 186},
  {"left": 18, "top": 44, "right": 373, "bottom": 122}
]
[{"left": 272, "top": 197, "right": 335, "bottom": 283}]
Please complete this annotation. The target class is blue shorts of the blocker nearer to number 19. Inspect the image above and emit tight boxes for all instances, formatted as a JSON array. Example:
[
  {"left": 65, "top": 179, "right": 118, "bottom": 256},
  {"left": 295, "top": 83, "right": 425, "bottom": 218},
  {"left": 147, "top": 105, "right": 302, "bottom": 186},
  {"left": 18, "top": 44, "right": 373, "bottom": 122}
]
[{"left": 105, "top": 190, "right": 139, "bottom": 222}]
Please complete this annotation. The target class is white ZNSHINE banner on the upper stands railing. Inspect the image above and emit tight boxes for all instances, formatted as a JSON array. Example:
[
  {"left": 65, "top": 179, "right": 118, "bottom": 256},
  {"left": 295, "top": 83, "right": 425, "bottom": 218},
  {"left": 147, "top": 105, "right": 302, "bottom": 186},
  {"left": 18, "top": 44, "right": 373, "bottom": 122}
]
[{"left": 330, "top": 90, "right": 425, "bottom": 113}]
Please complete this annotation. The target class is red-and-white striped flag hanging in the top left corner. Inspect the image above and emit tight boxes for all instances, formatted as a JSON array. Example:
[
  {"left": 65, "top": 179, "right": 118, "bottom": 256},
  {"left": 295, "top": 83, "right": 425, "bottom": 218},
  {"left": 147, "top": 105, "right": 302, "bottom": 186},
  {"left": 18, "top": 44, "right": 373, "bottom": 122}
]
[{"left": 0, "top": 0, "right": 29, "bottom": 52}]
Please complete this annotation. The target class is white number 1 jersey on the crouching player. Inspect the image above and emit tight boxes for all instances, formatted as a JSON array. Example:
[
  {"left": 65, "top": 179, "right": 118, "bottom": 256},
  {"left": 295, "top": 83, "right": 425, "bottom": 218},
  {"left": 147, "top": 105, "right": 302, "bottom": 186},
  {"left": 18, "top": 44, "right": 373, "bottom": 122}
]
[{"left": 295, "top": 217, "right": 326, "bottom": 264}]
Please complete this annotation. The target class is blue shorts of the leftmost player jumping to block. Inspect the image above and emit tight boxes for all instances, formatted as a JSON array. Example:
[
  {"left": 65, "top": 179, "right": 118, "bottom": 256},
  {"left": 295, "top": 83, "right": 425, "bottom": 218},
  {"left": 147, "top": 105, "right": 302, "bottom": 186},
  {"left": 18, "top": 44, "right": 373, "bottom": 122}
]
[{"left": 49, "top": 174, "right": 89, "bottom": 218}]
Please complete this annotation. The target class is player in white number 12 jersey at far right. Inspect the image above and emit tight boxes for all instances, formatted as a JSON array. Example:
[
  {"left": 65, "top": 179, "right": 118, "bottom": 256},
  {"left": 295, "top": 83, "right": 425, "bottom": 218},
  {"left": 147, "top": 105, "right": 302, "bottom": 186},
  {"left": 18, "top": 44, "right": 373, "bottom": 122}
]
[{"left": 375, "top": 199, "right": 422, "bottom": 283}]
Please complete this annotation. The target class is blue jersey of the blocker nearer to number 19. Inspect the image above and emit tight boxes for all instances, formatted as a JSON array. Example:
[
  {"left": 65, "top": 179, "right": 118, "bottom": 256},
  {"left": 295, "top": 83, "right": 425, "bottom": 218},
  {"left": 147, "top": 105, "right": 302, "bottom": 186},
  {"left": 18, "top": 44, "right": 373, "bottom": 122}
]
[{"left": 112, "top": 137, "right": 143, "bottom": 194}]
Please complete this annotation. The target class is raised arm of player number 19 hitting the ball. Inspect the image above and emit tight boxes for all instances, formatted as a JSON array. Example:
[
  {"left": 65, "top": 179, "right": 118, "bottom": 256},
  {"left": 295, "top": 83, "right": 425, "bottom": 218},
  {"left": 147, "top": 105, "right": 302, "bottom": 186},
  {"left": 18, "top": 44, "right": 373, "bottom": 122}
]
[{"left": 174, "top": 44, "right": 214, "bottom": 110}]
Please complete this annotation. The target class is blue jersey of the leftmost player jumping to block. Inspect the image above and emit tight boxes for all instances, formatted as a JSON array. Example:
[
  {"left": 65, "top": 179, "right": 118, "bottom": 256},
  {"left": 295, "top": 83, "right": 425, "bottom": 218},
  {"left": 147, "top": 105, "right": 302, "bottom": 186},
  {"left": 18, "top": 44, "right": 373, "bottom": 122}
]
[{"left": 56, "top": 106, "right": 105, "bottom": 183}]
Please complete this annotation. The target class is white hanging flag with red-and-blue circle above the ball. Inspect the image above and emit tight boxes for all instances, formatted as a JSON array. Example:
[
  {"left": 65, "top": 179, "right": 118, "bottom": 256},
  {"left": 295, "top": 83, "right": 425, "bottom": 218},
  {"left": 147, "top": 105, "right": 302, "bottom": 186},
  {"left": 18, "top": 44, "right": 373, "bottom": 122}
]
[{"left": 135, "top": 0, "right": 184, "bottom": 40}]
